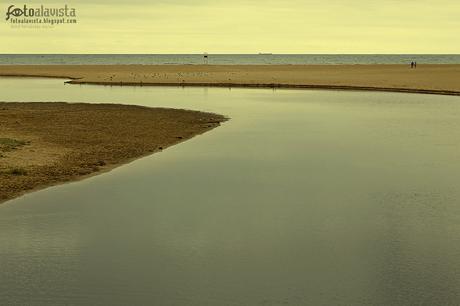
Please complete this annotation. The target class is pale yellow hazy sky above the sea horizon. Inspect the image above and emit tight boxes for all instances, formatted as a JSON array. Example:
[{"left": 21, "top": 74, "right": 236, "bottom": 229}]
[{"left": 0, "top": 0, "right": 460, "bottom": 54}]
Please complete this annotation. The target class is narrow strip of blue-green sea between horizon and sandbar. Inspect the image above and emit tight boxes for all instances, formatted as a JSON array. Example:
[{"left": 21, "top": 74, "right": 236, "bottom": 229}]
[{"left": 0, "top": 54, "right": 460, "bottom": 65}]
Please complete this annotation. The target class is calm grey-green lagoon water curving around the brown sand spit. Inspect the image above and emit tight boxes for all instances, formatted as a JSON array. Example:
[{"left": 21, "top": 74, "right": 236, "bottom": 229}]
[{"left": 0, "top": 78, "right": 460, "bottom": 306}]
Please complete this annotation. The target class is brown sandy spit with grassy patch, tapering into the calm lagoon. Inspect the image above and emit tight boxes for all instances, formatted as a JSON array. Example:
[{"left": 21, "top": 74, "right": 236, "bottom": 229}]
[{"left": 0, "top": 102, "right": 226, "bottom": 203}]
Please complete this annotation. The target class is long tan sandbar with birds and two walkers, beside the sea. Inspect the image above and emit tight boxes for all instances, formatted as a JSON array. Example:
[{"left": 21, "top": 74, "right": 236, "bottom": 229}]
[{"left": 0, "top": 65, "right": 460, "bottom": 95}]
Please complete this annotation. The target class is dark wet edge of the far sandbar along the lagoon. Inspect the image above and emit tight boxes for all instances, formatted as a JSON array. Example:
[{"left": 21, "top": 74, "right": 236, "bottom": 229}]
[{"left": 65, "top": 79, "right": 460, "bottom": 96}]
